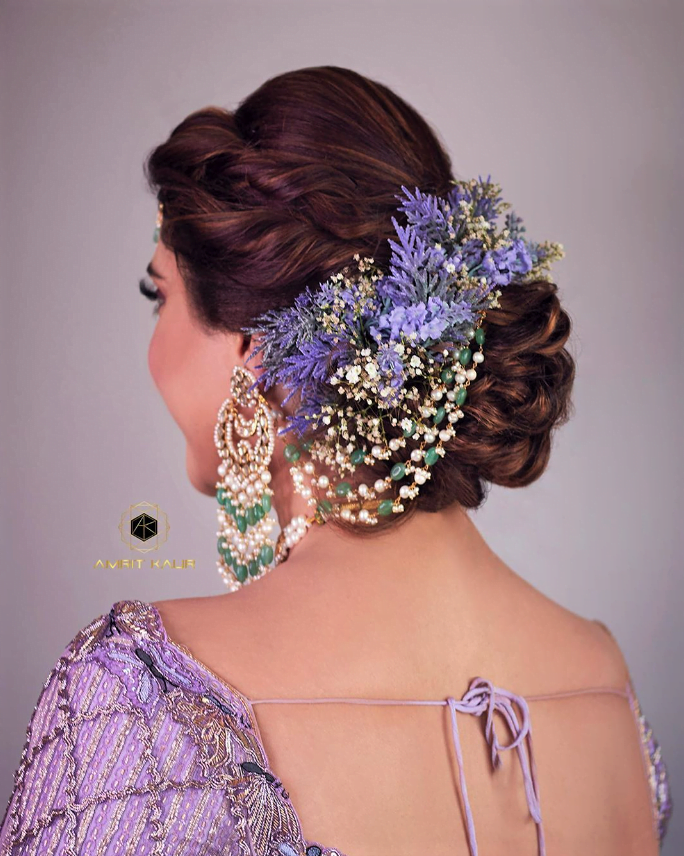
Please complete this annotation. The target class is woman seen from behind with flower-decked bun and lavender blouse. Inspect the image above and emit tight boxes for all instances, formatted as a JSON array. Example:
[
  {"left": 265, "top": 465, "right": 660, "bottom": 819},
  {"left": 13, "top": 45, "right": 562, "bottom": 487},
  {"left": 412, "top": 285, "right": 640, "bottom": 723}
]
[{"left": 0, "top": 66, "right": 672, "bottom": 856}]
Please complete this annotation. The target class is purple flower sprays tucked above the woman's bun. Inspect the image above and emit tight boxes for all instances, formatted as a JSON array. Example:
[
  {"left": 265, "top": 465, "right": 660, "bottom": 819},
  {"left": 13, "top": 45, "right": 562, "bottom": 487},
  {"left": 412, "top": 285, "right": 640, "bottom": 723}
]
[{"left": 243, "top": 176, "right": 564, "bottom": 434}]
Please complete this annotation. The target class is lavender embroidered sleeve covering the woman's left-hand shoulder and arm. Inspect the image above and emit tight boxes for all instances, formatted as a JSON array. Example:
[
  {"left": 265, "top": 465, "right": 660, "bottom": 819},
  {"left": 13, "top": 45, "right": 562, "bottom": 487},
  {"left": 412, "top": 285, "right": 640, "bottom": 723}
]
[{"left": 0, "top": 614, "right": 239, "bottom": 856}]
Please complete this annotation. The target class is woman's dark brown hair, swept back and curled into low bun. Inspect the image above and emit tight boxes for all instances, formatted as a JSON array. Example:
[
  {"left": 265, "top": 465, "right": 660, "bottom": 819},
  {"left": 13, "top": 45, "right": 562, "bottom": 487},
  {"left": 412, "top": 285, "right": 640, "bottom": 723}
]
[{"left": 145, "top": 66, "right": 575, "bottom": 533}]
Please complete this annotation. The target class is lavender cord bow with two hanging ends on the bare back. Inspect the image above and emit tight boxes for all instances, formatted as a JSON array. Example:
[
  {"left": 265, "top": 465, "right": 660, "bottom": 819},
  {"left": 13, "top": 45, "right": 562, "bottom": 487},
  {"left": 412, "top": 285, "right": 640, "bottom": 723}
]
[{"left": 446, "top": 678, "right": 546, "bottom": 856}]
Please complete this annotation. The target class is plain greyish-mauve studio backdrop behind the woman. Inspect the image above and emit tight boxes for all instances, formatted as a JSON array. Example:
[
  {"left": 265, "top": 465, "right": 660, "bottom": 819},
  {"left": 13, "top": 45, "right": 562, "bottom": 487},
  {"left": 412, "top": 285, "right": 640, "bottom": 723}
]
[{"left": 0, "top": 0, "right": 684, "bottom": 854}]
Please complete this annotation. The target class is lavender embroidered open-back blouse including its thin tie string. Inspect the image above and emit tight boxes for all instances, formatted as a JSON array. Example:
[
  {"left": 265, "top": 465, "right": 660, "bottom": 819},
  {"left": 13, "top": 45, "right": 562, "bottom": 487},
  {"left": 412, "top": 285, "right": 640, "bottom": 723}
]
[{"left": 0, "top": 600, "right": 672, "bottom": 856}]
